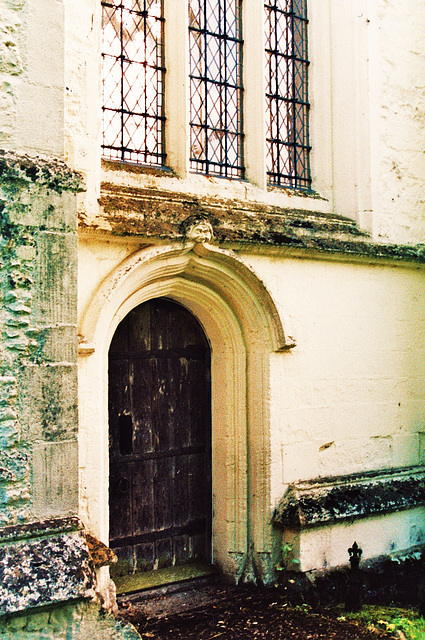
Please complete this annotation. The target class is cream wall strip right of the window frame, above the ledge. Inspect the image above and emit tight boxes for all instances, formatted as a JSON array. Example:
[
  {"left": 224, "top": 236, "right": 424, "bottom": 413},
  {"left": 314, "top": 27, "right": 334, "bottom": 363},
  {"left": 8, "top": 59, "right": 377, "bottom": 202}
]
[{"left": 368, "top": 0, "right": 425, "bottom": 243}]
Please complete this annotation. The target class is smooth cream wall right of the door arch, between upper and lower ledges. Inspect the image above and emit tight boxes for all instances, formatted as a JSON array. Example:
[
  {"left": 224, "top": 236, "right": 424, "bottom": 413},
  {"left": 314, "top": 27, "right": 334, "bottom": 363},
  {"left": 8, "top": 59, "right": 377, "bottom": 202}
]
[{"left": 240, "top": 255, "right": 425, "bottom": 504}]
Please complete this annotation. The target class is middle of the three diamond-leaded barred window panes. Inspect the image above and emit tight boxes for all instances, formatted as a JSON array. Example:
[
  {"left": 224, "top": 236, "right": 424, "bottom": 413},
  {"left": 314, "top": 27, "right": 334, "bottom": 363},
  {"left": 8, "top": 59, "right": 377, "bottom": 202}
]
[{"left": 189, "top": 0, "right": 244, "bottom": 178}]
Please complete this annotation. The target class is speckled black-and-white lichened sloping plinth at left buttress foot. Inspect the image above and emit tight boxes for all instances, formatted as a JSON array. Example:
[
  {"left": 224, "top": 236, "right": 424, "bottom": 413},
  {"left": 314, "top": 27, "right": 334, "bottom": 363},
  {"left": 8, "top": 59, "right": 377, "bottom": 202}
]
[{"left": 0, "top": 518, "right": 94, "bottom": 616}]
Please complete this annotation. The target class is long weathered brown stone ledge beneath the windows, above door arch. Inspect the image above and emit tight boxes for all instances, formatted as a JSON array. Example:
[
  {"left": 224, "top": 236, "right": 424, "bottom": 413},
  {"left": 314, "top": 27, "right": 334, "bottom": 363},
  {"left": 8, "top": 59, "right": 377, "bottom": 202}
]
[{"left": 86, "top": 182, "right": 425, "bottom": 264}]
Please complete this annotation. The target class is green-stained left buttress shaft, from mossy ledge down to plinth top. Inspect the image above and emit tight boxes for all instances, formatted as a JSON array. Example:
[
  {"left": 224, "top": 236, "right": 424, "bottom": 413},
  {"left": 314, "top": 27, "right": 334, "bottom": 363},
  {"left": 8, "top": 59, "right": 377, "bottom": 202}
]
[{"left": 0, "top": 153, "right": 80, "bottom": 526}]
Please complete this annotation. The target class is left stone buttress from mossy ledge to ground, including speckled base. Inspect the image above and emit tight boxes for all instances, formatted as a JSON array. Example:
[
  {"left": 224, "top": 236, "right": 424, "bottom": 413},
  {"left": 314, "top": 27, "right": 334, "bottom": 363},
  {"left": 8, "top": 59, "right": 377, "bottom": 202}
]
[{"left": 0, "top": 152, "right": 137, "bottom": 639}]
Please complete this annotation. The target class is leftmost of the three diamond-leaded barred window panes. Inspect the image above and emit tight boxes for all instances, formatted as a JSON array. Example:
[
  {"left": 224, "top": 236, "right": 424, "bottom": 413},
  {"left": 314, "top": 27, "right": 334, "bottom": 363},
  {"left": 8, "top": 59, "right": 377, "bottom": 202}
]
[{"left": 102, "top": 0, "right": 165, "bottom": 166}]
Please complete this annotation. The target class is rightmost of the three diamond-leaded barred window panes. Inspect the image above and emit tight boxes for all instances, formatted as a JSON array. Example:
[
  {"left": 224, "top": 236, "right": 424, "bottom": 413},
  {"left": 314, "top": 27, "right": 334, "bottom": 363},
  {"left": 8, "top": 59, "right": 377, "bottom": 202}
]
[{"left": 264, "top": 0, "right": 311, "bottom": 189}]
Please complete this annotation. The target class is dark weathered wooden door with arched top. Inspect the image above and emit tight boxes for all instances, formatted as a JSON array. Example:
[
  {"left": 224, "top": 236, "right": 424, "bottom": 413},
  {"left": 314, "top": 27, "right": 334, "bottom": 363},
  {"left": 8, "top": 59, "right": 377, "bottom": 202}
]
[{"left": 109, "top": 298, "right": 211, "bottom": 575}]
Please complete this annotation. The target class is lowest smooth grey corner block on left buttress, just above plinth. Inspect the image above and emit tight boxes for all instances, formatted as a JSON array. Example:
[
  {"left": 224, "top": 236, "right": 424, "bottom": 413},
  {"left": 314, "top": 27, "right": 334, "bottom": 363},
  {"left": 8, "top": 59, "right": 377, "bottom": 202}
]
[{"left": 33, "top": 441, "right": 78, "bottom": 518}]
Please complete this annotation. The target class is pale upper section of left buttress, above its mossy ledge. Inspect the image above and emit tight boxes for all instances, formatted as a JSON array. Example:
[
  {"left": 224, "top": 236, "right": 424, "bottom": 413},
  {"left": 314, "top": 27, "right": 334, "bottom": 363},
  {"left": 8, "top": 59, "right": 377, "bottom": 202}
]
[{"left": 0, "top": 0, "right": 64, "bottom": 158}]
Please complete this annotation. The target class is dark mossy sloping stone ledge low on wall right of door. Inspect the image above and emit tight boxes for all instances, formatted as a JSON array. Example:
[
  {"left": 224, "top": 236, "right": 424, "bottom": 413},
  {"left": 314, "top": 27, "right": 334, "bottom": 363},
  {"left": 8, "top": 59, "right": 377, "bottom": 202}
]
[{"left": 272, "top": 466, "right": 425, "bottom": 528}]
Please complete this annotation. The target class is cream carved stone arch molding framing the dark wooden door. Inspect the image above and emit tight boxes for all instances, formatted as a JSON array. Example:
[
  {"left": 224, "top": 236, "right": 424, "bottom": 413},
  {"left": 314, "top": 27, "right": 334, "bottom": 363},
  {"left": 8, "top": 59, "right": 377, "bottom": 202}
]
[{"left": 79, "top": 243, "right": 294, "bottom": 581}]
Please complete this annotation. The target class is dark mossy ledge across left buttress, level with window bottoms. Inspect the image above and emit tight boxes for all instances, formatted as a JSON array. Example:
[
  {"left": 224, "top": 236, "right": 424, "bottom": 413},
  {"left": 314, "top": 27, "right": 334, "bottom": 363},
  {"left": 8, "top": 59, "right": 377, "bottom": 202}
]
[{"left": 0, "top": 149, "right": 84, "bottom": 193}]
